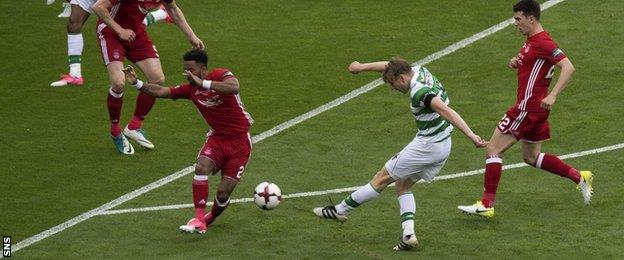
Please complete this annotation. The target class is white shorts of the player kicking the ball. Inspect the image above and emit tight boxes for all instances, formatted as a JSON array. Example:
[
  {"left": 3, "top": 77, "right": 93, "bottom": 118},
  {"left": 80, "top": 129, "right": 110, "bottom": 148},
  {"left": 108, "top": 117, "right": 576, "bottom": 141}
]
[{"left": 385, "top": 136, "right": 451, "bottom": 182}]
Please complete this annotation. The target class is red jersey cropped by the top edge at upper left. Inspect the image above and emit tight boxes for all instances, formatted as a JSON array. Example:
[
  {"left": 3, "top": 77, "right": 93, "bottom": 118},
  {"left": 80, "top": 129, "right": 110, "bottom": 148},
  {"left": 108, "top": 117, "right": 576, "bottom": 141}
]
[{"left": 97, "top": 0, "right": 173, "bottom": 34}]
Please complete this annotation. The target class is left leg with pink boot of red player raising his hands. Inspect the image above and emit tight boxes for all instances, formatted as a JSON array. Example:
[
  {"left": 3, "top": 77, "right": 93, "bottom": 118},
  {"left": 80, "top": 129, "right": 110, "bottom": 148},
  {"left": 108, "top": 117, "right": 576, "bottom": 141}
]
[{"left": 180, "top": 156, "right": 216, "bottom": 233}]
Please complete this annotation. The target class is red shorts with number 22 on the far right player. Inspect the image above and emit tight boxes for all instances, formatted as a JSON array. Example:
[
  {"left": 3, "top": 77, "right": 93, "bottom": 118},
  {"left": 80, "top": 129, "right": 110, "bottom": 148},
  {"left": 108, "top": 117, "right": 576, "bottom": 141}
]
[{"left": 498, "top": 107, "right": 550, "bottom": 143}]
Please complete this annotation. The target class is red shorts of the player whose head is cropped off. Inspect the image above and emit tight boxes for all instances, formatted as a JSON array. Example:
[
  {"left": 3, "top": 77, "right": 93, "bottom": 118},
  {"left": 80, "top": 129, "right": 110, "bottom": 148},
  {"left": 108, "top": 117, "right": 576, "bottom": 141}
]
[{"left": 97, "top": 27, "right": 158, "bottom": 65}]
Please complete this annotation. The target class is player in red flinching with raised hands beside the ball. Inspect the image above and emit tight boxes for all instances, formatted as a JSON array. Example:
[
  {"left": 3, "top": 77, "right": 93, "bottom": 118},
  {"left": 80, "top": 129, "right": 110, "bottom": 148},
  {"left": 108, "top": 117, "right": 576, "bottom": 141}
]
[{"left": 124, "top": 49, "right": 253, "bottom": 233}]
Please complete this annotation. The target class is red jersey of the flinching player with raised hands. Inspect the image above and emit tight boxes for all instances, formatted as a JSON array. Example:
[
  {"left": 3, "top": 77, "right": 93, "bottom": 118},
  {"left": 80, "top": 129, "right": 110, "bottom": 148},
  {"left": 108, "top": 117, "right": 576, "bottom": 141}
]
[{"left": 170, "top": 68, "right": 253, "bottom": 137}]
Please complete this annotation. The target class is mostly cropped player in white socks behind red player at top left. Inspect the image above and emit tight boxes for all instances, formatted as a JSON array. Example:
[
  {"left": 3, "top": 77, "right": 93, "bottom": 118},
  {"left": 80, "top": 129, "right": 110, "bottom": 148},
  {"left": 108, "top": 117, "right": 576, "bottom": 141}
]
[{"left": 48, "top": 0, "right": 170, "bottom": 87}]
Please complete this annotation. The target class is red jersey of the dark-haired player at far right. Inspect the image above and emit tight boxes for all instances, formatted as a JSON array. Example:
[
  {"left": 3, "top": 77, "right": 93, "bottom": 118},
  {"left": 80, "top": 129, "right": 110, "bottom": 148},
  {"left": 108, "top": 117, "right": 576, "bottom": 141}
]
[{"left": 514, "top": 31, "right": 566, "bottom": 111}]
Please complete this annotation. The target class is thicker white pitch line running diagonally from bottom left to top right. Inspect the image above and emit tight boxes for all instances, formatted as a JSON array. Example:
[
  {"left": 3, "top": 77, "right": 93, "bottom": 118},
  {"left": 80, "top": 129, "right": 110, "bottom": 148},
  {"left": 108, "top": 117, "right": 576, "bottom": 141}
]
[{"left": 6, "top": 0, "right": 565, "bottom": 258}]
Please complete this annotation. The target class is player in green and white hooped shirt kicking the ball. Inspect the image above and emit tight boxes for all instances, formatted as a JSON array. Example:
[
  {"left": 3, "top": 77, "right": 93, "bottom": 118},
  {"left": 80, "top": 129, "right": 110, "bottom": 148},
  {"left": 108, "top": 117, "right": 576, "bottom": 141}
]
[{"left": 313, "top": 58, "right": 487, "bottom": 250}]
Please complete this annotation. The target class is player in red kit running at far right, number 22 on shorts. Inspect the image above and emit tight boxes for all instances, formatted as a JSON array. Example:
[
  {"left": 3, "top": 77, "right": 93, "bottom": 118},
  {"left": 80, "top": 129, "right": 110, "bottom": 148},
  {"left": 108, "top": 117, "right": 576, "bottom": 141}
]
[{"left": 458, "top": 0, "right": 593, "bottom": 218}]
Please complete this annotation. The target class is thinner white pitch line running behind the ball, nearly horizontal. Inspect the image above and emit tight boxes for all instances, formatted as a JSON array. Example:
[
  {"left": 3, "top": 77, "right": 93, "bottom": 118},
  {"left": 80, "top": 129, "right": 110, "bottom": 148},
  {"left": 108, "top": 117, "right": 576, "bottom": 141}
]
[{"left": 100, "top": 143, "right": 624, "bottom": 215}]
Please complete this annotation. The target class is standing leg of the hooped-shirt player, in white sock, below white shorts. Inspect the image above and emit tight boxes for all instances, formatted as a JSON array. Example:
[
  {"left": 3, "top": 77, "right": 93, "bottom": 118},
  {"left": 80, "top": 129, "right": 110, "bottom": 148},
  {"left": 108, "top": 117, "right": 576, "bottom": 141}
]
[{"left": 393, "top": 178, "right": 418, "bottom": 250}]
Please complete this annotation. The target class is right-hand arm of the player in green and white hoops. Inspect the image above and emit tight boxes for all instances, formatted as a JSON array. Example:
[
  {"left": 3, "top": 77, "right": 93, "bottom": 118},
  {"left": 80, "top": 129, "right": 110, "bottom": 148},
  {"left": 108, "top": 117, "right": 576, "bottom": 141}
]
[{"left": 424, "top": 94, "right": 487, "bottom": 147}]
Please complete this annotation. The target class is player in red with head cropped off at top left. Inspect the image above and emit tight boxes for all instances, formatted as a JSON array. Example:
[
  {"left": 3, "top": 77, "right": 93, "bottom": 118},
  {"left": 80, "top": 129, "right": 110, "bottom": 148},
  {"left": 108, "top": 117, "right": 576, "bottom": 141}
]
[{"left": 92, "top": 0, "right": 204, "bottom": 154}]
